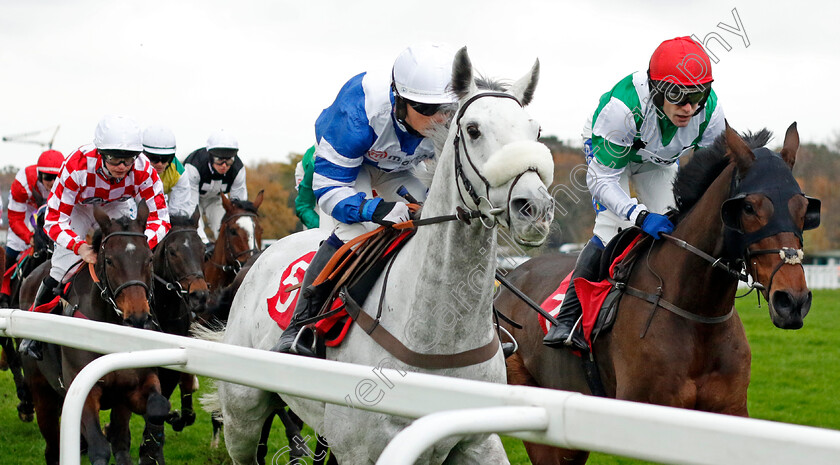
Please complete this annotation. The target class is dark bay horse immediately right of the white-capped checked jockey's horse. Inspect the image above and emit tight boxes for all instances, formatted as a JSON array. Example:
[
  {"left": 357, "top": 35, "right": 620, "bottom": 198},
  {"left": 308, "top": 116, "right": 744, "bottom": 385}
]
[{"left": 152, "top": 208, "right": 210, "bottom": 431}]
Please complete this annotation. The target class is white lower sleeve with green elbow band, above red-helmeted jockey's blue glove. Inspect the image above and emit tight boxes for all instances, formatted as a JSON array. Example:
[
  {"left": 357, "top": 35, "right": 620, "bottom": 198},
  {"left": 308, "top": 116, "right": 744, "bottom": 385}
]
[{"left": 586, "top": 136, "right": 647, "bottom": 222}]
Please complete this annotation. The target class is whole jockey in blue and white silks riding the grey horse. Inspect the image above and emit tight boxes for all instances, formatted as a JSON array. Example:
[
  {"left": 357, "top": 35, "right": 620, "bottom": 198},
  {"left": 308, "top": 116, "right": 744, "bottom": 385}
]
[{"left": 272, "top": 45, "right": 455, "bottom": 355}]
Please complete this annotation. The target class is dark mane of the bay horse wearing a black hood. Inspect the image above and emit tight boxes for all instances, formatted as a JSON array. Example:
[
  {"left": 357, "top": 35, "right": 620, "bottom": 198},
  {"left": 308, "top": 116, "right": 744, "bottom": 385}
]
[{"left": 674, "top": 128, "right": 773, "bottom": 221}]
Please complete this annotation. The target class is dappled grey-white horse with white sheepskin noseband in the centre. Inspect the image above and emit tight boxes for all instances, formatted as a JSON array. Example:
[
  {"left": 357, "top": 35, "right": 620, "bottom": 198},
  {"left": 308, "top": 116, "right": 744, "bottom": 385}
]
[{"left": 213, "top": 48, "right": 554, "bottom": 465}]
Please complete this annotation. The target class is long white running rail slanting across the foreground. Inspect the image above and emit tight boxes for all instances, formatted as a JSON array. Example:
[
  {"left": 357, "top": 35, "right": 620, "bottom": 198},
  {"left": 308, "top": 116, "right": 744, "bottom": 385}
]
[{"left": 0, "top": 309, "right": 840, "bottom": 465}]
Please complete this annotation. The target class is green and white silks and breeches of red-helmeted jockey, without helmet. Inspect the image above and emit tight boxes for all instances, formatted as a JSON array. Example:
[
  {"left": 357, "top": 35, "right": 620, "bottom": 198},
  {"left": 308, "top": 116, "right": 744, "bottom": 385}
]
[{"left": 584, "top": 71, "right": 724, "bottom": 245}]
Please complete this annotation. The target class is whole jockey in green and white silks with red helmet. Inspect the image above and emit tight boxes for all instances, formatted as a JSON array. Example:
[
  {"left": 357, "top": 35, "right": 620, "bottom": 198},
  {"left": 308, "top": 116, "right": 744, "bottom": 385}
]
[{"left": 543, "top": 37, "right": 726, "bottom": 351}]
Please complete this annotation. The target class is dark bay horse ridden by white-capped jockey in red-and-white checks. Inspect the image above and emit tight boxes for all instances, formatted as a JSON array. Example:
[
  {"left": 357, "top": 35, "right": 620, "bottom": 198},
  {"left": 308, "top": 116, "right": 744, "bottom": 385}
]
[{"left": 21, "top": 202, "right": 169, "bottom": 465}]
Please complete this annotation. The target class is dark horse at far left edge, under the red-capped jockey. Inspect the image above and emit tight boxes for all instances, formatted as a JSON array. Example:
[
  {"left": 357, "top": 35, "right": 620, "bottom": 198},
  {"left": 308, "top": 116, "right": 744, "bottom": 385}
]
[{"left": 0, "top": 205, "right": 54, "bottom": 423}]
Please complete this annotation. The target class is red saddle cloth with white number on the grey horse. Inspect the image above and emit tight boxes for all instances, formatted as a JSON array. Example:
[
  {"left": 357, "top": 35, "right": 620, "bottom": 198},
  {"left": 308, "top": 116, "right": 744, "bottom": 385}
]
[{"left": 266, "top": 251, "right": 352, "bottom": 347}]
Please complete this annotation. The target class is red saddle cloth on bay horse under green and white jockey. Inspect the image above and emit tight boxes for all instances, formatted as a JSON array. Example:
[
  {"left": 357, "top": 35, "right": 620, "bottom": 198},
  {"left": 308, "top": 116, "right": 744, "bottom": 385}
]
[{"left": 539, "top": 234, "right": 643, "bottom": 350}]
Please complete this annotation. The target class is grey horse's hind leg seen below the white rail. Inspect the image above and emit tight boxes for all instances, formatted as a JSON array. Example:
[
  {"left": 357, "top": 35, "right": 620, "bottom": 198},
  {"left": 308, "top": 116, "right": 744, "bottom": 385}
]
[{"left": 219, "top": 383, "right": 275, "bottom": 465}]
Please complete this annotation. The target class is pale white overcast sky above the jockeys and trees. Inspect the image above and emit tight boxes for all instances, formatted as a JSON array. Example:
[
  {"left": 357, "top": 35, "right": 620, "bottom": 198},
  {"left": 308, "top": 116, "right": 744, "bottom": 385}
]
[{"left": 0, "top": 0, "right": 840, "bottom": 166}]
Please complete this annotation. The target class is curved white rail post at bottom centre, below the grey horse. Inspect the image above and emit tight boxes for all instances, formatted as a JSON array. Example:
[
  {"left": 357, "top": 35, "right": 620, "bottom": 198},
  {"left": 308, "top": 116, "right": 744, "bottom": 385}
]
[{"left": 376, "top": 407, "right": 548, "bottom": 465}]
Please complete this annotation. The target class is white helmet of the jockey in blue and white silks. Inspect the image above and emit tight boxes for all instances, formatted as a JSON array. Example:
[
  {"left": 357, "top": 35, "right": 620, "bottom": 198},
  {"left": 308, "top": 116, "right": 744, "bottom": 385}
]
[{"left": 391, "top": 44, "right": 456, "bottom": 104}]
